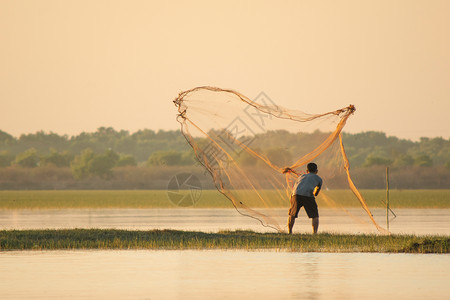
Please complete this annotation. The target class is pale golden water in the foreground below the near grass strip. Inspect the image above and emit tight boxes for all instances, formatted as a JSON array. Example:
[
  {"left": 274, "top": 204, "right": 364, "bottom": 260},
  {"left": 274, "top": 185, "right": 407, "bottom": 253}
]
[{"left": 0, "top": 250, "right": 450, "bottom": 299}]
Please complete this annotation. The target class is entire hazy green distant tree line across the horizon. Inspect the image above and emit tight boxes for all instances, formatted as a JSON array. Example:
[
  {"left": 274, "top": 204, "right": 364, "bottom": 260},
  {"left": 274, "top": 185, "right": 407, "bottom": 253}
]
[{"left": 0, "top": 127, "right": 450, "bottom": 188}]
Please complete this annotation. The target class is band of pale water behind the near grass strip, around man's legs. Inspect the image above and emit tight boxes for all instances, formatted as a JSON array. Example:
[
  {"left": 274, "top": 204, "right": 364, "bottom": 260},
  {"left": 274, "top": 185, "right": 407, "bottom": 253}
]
[{"left": 0, "top": 208, "right": 450, "bottom": 235}]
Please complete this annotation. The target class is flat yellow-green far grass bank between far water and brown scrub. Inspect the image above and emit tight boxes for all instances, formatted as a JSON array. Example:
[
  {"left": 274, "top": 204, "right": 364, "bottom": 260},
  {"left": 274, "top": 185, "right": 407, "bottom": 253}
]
[{"left": 0, "top": 190, "right": 450, "bottom": 209}]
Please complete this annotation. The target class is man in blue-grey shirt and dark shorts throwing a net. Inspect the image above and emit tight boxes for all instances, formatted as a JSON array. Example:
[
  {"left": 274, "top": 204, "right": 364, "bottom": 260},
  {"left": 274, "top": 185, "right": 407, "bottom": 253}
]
[{"left": 288, "top": 163, "right": 322, "bottom": 234}]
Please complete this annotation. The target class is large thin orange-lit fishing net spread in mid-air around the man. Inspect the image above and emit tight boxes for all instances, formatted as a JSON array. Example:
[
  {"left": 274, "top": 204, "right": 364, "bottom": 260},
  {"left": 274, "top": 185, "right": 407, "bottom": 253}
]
[{"left": 174, "top": 86, "right": 384, "bottom": 232}]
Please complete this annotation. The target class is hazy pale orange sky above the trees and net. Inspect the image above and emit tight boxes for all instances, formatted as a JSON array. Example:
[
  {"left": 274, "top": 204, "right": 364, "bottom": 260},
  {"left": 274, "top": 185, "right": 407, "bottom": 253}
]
[{"left": 0, "top": 0, "right": 450, "bottom": 139}]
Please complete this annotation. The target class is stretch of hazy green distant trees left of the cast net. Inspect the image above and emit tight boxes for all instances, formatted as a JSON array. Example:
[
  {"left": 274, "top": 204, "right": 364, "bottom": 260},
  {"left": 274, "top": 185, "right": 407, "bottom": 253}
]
[{"left": 0, "top": 127, "right": 194, "bottom": 179}]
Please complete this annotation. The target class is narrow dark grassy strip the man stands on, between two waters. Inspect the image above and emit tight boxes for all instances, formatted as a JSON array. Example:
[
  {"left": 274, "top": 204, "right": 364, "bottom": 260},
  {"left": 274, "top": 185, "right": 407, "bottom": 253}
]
[{"left": 0, "top": 229, "right": 450, "bottom": 253}]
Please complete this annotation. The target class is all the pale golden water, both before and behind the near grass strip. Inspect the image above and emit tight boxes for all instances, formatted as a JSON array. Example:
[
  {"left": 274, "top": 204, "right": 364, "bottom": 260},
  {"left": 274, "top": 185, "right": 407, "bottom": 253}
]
[{"left": 0, "top": 208, "right": 450, "bottom": 299}]
